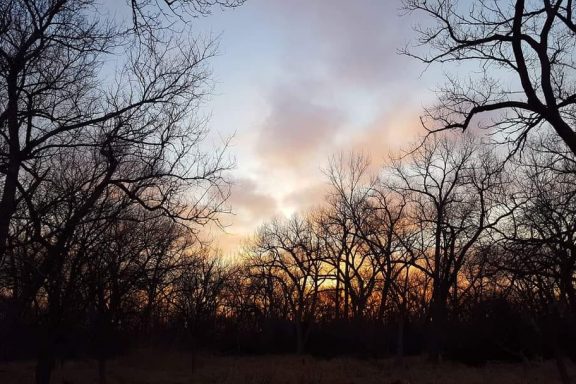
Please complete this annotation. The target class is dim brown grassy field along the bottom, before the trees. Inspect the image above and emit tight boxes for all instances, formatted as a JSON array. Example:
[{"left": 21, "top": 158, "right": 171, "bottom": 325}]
[{"left": 0, "top": 351, "right": 560, "bottom": 384}]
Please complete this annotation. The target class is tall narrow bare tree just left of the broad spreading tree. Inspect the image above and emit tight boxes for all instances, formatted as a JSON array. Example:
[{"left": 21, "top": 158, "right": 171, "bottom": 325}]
[{"left": 323, "top": 155, "right": 406, "bottom": 322}]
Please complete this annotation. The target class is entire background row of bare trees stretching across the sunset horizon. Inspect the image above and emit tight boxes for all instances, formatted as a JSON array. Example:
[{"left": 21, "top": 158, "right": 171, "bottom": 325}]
[{"left": 6, "top": 132, "right": 576, "bottom": 375}]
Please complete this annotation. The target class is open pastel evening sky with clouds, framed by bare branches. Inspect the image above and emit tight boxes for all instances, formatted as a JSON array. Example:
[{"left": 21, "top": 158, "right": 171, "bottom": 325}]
[{"left": 106, "top": 0, "right": 441, "bottom": 255}]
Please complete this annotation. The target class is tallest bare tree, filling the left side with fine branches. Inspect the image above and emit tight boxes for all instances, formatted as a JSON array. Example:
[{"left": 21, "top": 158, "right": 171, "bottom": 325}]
[{"left": 0, "top": 0, "right": 228, "bottom": 383}]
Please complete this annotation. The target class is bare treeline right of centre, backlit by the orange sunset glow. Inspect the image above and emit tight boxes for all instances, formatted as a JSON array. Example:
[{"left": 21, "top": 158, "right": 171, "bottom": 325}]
[{"left": 234, "top": 136, "right": 576, "bottom": 364}]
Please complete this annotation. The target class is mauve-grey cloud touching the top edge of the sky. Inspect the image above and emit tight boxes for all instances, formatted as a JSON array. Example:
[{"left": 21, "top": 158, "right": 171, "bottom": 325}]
[{"left": 260, "top": 0, "right": 415, "bottom": 88}]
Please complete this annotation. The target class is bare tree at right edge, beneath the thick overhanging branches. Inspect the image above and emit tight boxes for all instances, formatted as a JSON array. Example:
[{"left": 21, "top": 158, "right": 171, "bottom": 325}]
[{"left": 492, "top": 135, "right": 576, "bottom": 383}]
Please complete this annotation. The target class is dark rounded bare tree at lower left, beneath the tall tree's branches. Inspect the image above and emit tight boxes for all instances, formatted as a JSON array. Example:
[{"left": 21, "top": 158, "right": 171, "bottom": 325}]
[{"left": 84, "top": 207, "right": 193, "bottom": 384}]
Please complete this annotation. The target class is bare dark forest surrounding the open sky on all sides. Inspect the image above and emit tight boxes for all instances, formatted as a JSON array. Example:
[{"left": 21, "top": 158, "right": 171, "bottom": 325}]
[{"left": 0, "top": 0, "right": 576, "bottom": 384}]
